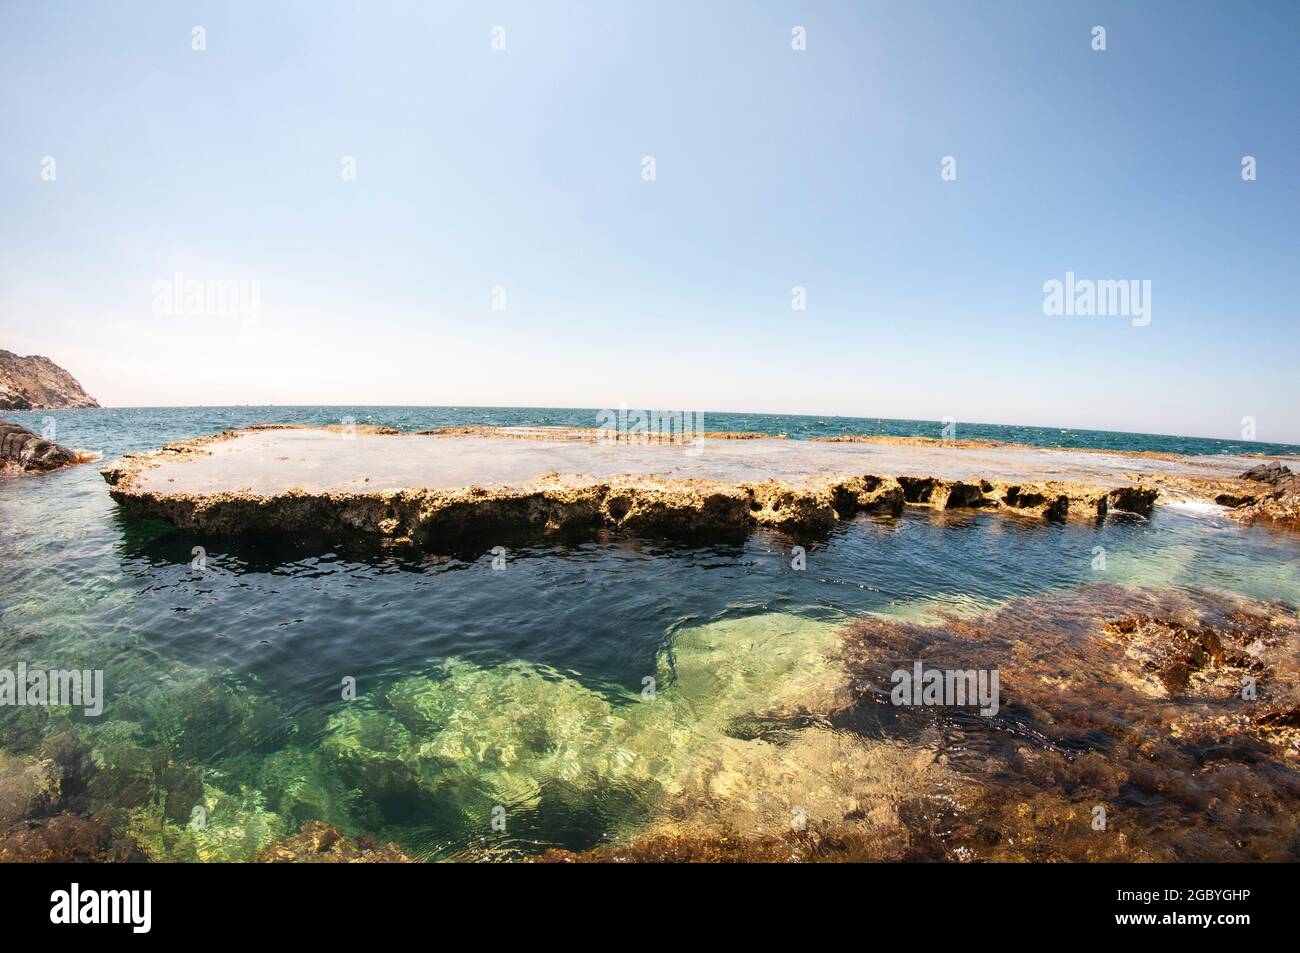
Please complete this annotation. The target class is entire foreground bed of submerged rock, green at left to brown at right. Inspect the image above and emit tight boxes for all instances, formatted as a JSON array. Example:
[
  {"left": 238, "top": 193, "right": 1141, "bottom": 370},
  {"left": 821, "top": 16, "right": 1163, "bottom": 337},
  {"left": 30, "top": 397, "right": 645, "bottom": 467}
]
[{"left": 0, "top": 584, "right": 1300, "bottom": 862}]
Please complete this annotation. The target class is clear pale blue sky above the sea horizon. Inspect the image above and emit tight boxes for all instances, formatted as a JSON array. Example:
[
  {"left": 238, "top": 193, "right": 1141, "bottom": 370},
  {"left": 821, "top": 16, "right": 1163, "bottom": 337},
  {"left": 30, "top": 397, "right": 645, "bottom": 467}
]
[{"left": 0, "top": 0, "right": 1300, "bottom": 441}]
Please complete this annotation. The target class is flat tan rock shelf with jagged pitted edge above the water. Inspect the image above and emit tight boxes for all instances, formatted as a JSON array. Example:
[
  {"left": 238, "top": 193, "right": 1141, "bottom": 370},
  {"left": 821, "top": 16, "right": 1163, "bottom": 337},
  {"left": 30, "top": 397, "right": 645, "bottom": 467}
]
[{"left": 101, "top": 425, "right": 1295, "bottom": 545}]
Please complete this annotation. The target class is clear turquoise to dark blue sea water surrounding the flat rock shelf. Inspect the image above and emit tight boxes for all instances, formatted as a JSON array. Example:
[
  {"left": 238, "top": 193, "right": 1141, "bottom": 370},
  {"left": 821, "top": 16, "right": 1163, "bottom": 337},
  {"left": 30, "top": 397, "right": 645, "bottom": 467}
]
[{"left": 0, "top": 408, "right": 1300, "bottom": 859}]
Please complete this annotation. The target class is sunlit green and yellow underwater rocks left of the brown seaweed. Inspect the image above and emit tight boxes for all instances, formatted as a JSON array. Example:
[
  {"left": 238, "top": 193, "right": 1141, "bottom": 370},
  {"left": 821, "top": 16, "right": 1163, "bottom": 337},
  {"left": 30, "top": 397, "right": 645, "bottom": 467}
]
[{"left": 5, "top": 614, "right": 894, "bottom": 861}]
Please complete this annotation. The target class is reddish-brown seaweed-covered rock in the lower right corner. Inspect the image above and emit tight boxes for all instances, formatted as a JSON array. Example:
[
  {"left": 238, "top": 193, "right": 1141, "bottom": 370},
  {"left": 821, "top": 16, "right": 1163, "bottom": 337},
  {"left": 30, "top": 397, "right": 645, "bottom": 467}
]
[{"left": 845, "top": 585, "right": 1300, "bottom": 861}]
